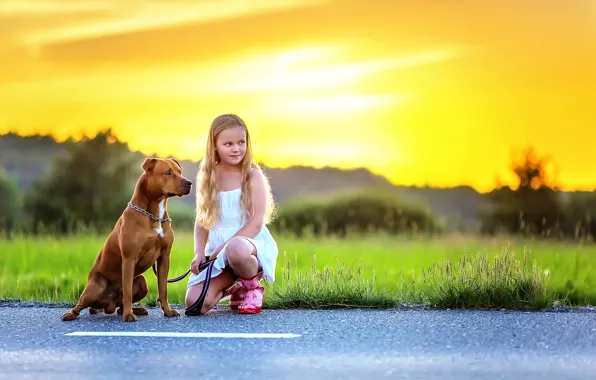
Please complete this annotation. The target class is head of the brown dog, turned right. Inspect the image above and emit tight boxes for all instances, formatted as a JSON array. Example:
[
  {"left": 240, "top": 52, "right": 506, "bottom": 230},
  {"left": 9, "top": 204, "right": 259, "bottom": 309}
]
[{"left": 141, "top": 158, "right": 192, "bottom": 197}]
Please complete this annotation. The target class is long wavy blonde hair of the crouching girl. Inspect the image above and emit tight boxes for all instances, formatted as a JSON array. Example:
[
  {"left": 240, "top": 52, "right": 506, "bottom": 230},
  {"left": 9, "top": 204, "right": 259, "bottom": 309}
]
[{"left": 195, "top": 114, "right": 275, "bottom": 229}]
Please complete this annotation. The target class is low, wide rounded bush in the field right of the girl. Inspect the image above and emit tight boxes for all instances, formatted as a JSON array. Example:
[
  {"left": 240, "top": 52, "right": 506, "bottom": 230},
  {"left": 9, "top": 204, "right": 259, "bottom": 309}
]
[{"left": 272, "top": 189, "right": 440, "bottom": 237}]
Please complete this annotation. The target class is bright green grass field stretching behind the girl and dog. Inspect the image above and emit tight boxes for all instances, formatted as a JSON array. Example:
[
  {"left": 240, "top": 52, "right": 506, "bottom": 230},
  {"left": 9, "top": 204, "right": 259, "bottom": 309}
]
[{"left": 0, "top": 232, "right": 596, "bottom": 309}]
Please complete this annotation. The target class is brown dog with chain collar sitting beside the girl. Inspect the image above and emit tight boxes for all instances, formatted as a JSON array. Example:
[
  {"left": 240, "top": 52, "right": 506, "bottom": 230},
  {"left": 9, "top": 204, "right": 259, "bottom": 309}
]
[{"left": 62, "top": 158, "right": 192, "bottom": 322}]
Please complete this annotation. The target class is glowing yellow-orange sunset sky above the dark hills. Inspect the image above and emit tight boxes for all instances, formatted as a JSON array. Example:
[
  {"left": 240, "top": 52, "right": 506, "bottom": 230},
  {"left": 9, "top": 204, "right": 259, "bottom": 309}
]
[{"left": 0, "top": 0, "right": 596, "bottom": 191}]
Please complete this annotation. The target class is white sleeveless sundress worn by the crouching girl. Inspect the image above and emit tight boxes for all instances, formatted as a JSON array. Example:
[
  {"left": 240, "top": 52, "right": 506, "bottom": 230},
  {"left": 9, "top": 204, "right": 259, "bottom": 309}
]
[{"left": 187, "top": 188, "right": 279, "bottom": 288}]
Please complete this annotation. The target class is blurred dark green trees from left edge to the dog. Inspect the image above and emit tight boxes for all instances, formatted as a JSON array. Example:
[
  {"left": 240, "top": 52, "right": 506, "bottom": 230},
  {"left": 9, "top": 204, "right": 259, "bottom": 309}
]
[{"left": 0, "top": 129, "right": 139, "bottom": 237}]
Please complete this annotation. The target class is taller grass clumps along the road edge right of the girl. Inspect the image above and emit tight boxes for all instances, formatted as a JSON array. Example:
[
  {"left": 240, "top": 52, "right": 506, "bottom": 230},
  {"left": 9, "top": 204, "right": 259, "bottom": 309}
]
[{"left": 268, "top": 243, "right": 552, "bottom": 310}]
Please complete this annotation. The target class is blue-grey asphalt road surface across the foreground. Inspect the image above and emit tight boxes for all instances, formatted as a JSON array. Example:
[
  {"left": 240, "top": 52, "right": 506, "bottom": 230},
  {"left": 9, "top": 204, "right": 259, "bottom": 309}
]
[{"left": 0, "top": 307, "right": 596, "bottom": 380}]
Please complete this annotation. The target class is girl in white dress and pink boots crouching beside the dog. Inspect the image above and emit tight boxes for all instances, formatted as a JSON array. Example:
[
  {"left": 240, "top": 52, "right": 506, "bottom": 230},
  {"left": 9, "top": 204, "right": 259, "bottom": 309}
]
[{"left": 186, "top": 114, "right": 278, "bottom": 315}]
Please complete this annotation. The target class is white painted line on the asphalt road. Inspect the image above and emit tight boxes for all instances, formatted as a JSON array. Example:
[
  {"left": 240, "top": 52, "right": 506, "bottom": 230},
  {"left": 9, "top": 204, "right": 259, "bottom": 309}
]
[{"left": 64, "top": 331, "right": 302, "bottom": 339}]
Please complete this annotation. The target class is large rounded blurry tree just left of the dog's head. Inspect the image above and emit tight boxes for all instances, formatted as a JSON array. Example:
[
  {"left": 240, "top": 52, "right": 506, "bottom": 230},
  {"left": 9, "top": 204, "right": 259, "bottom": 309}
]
[{"left": 26, "top": 129, "right": 140, "bottom": 233}]
